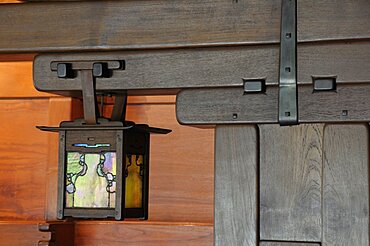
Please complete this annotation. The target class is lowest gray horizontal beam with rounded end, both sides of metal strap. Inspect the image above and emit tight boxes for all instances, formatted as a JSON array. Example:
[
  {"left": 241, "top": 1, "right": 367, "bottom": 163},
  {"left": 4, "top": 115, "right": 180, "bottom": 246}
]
[{"left": 176, "top": 83, "right": 370, "bottom": 125}]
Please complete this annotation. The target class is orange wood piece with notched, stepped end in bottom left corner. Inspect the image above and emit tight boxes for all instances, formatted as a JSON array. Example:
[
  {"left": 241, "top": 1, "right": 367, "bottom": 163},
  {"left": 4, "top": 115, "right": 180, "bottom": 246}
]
[{"left": 0, "top": 221, "right": 51, "bottom": 246}]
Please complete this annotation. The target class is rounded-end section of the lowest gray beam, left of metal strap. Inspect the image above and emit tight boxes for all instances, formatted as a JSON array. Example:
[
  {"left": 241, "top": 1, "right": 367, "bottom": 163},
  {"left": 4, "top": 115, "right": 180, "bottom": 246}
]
[{"left": 176, "top": 87, "right": 278, "bottom": 124}]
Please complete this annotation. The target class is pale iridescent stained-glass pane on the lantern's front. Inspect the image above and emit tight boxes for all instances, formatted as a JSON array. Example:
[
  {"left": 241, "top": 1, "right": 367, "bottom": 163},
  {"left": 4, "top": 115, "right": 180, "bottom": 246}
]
[{"left": 65, "top": 152, "right": 116, "bottom": 208}]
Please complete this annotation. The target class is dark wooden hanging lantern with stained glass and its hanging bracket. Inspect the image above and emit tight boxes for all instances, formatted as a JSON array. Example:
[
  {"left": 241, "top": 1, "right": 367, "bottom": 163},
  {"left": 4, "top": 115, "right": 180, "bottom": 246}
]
[{"left": 38, "top": 62, "right": 170, "bottom": 220}]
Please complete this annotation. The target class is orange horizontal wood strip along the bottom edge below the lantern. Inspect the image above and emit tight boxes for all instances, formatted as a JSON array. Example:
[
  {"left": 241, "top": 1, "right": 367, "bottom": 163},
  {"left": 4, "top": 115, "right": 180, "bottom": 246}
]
[{"left": 75, "top": 222, "right": 213, "bottom": 246}]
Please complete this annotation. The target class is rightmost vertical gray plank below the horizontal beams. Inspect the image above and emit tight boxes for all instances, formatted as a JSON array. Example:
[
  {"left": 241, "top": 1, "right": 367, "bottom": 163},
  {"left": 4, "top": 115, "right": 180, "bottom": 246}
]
[{"left": 323, "top": 125, "right": 369, "bottom": 246}]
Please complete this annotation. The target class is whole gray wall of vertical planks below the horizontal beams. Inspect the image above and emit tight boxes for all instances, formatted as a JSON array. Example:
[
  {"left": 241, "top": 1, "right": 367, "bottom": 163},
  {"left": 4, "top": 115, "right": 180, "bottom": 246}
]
[{"left": 215, "top": 124, "right": 369, "bottom": 246}]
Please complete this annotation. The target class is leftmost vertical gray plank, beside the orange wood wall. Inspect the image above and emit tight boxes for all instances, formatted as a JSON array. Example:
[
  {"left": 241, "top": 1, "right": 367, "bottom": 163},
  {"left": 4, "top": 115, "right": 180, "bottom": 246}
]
[{"left": 215, "top": 126, "right": 258, "bottom": 246}]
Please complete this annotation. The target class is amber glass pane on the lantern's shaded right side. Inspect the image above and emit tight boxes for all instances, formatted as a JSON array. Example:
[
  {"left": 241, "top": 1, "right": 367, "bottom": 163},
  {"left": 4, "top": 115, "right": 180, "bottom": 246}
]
[{"left": 125, "top": 154, "right": 144, "bottom": 208}]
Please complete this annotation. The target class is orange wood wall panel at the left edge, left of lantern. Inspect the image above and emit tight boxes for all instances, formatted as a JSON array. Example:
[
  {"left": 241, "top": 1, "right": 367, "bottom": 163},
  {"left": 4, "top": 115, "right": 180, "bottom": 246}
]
[{"left": 0, "top": 99, "right": 49, "bottom": 220}]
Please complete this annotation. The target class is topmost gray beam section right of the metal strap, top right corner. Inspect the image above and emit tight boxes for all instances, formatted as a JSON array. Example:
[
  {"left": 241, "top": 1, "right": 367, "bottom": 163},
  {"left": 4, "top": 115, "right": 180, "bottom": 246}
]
[{"left": 297, "top": 0, "right": 370, "bottom": 42}]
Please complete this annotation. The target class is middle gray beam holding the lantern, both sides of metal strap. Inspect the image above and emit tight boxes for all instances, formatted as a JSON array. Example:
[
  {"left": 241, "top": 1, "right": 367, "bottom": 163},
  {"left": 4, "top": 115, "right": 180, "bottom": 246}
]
[{"left": 34, "top": 41, "right": 370, "bottom": 95}]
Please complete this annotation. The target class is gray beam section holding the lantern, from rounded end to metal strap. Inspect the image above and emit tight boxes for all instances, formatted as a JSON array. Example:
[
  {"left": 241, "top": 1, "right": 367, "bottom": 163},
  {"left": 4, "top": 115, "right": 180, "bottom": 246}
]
[{"left": 34, "top": 45, "right": 279, "bottom": 93}]
